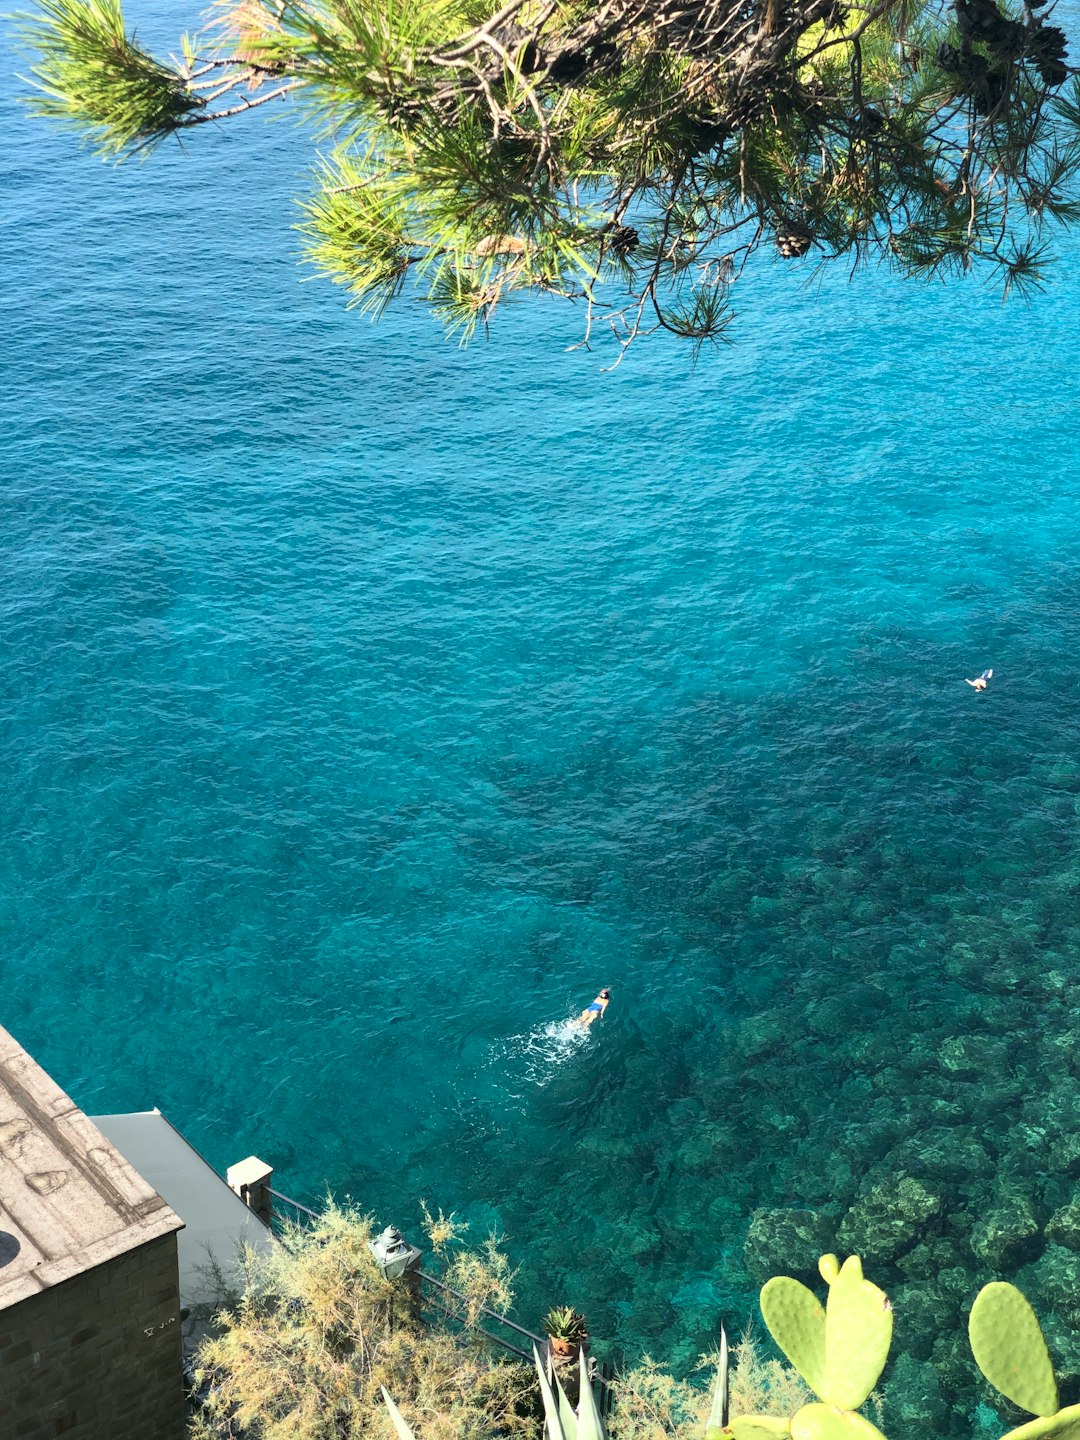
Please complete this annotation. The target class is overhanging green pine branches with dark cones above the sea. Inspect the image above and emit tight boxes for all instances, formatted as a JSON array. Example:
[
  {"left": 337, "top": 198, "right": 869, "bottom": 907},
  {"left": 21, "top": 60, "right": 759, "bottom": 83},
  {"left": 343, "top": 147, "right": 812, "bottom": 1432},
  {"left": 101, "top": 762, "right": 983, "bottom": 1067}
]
[{"left": 16, "top": 0, "right": 1080, "bottom": 357}]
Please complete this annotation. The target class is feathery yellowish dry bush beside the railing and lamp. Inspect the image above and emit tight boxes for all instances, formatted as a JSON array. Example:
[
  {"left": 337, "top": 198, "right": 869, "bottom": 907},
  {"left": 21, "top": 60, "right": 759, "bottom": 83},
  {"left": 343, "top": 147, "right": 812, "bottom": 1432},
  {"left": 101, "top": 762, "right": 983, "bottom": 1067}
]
[{"left": 193, "top": 1205, "right": 534, "bottom": 1440}]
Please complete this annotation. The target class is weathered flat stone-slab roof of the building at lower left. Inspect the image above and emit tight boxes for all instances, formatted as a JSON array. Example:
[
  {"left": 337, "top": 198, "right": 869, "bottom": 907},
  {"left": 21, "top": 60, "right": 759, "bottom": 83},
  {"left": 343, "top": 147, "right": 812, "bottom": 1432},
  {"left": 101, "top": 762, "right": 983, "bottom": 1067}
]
[{"left": 0, "top": 1028, "right": 183, "bottom": 1309}]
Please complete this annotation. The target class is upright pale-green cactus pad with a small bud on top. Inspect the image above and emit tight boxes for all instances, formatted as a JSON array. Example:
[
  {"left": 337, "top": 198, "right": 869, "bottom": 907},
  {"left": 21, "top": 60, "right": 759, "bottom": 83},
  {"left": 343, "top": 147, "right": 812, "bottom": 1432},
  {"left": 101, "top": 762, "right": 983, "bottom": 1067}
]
[{"left": 815, "top": 1256, "right": 893, "bottom": 1410}]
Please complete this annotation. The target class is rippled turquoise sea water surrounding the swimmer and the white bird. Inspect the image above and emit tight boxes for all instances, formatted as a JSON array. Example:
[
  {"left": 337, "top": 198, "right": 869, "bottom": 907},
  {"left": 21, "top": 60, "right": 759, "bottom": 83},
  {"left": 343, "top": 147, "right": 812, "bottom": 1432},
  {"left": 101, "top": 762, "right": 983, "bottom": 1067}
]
[{"left": 0, "top": 0, "right": 1080, "bottom": 1428}]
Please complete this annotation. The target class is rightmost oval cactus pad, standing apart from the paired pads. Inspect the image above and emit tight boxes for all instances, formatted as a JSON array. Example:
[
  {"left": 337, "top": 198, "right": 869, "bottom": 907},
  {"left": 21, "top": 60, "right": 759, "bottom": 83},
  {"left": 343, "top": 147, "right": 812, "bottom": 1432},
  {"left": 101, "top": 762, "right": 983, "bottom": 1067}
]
[{"left": 968, "top": 1280, "right": 1059, "bottom": 1416}]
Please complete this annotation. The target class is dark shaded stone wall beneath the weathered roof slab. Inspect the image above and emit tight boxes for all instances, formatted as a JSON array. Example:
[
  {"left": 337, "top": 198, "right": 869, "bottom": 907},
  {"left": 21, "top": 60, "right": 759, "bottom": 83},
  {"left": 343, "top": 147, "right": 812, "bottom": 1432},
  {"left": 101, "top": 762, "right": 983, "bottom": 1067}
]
[{"left": 0, "top": 1234, "right": 184, "bottom": 1440}]
